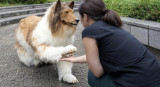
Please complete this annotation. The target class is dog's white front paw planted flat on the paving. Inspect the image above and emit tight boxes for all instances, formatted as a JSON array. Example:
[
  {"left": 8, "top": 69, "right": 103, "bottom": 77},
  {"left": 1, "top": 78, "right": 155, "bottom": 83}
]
[{"left": 62, "top": 74, "right": 78, "bottom": 83}]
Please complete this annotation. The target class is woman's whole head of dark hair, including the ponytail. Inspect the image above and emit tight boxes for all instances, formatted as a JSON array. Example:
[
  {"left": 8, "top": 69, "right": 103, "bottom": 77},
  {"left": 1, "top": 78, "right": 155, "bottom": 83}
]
[{"left": 78, "top": 0, "right": 122, "bottom": 27}]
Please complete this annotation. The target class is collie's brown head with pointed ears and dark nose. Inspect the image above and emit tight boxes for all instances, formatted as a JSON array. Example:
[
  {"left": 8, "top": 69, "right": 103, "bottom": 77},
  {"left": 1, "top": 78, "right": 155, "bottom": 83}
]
[{"left": 49, "top": 0, "right": 79, "bottom": 35}]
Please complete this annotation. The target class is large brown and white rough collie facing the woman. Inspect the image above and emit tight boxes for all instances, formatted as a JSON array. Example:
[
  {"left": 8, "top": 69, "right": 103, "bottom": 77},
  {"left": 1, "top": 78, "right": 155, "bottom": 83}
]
[{"left": 15, "top": 0, "right": 79, "bottom": 83}]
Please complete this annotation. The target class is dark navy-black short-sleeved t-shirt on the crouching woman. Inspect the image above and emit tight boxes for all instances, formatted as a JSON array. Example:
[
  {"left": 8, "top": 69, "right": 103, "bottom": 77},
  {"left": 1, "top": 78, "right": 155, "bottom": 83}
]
[{"left": 82, "top": 21, "right": 160, "bottom": 87}]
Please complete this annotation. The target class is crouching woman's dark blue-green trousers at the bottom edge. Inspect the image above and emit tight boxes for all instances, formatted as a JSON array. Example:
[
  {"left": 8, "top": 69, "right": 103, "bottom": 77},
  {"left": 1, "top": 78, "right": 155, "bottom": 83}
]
[{"left": 88, "top": 70, "right": 115, "bottom": 87}]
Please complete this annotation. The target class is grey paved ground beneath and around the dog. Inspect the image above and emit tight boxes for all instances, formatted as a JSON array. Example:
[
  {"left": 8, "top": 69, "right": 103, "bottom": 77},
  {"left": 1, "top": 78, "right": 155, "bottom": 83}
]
[{"left": 0, "top": 12, "right": 160, "bottom": 87}]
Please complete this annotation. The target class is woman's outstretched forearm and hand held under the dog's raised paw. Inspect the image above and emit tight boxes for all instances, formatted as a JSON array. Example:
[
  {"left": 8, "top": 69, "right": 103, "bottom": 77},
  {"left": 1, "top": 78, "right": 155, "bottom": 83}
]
[{"left": 60, "top": 55, "right": 86, "bottom": 63}]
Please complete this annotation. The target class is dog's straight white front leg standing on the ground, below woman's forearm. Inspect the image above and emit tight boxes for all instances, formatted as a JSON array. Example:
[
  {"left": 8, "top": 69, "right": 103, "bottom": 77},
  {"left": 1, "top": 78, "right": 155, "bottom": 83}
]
[{"left": 57, "top": 61, "right": 78, "bottom": 83}]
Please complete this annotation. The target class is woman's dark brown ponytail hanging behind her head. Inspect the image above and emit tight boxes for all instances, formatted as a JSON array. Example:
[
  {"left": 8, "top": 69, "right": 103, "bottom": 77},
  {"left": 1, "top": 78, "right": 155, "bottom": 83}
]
[{"left": 102, "top": 10, "right": 122, "bottom": 27}]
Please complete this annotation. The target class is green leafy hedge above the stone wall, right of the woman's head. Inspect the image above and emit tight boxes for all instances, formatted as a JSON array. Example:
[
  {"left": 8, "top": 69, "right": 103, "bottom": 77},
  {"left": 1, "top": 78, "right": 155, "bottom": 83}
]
[{"left": 104, "top": 0, "right": 160, "bottom": 22}]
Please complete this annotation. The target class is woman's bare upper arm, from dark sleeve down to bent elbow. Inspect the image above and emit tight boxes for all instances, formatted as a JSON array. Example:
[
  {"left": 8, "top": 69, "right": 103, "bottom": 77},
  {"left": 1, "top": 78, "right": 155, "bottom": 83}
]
[{"left": 83, "top": 37, "right": 104, "bottom": 78}]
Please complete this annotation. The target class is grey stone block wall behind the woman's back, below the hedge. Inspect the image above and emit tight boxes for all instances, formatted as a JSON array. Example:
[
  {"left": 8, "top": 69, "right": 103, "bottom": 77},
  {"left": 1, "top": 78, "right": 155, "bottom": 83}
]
[{"left": 121, "top": 17, "right": 160, "bottom": 50}]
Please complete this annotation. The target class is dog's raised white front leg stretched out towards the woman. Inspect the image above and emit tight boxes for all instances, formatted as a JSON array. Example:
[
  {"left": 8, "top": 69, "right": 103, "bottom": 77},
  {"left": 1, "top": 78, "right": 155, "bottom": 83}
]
[{"left": 35, "top": 44, "right": 77, "bottom": 63}]
